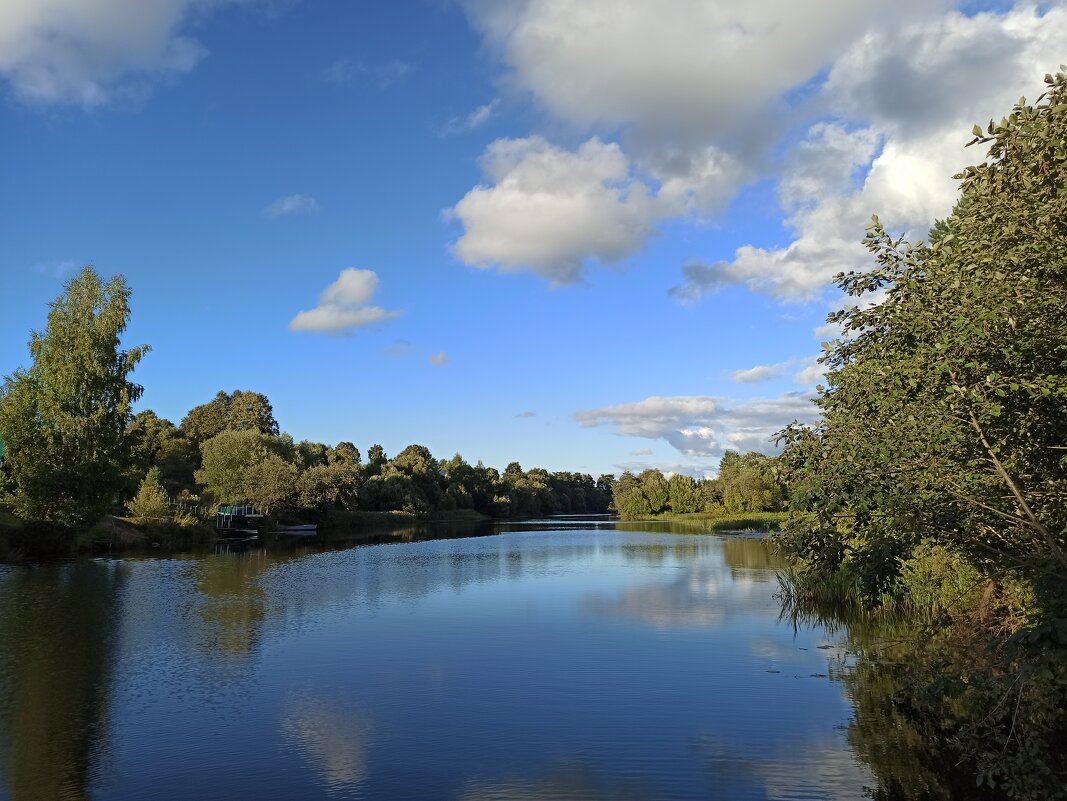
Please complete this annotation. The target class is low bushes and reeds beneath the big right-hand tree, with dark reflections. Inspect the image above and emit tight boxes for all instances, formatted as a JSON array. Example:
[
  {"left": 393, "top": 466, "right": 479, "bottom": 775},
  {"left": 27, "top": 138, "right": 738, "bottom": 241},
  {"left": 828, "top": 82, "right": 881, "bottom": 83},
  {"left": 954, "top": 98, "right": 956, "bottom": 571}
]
[{"left": 779, "top": 543, "right": 1067, "bottom": 801}]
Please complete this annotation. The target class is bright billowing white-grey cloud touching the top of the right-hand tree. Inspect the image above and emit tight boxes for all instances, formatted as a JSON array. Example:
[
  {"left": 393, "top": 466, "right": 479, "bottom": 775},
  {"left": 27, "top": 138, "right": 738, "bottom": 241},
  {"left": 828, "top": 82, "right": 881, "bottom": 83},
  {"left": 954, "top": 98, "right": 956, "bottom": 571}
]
[{"left": 671, "top": 5, "right": 1067, "bottom": 302}]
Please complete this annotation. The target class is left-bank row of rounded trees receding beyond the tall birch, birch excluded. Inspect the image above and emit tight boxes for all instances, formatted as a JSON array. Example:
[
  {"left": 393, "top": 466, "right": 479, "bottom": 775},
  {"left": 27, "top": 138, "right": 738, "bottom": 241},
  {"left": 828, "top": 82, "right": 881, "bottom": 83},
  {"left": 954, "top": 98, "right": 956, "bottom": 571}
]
[{"left": 123, "top": 390, "right": 614, "bottom": 517}]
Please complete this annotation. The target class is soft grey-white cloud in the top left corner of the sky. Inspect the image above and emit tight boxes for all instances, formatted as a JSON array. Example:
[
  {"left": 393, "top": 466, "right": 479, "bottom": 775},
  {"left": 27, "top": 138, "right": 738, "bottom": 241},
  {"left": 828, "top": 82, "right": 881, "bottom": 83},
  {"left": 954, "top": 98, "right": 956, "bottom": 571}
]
[{"left": 0, "top": 0, "right": 254, "bottom": 107}]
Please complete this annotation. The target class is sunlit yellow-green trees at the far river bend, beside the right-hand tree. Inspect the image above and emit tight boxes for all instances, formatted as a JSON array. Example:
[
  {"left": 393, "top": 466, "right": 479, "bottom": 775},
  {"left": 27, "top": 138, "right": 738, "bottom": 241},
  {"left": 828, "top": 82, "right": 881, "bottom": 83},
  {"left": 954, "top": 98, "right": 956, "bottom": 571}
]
[{"left": 612, "top": 450, "right": 786, "bottom": 520}]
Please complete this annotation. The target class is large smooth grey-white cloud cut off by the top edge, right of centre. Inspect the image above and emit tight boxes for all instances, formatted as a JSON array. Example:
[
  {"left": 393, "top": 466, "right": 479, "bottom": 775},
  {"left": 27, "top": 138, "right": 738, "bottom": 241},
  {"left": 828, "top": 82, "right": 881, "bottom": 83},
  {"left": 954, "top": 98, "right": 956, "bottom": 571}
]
[{"left": 465, "top": 0, "right": 940, "bottom": 143}]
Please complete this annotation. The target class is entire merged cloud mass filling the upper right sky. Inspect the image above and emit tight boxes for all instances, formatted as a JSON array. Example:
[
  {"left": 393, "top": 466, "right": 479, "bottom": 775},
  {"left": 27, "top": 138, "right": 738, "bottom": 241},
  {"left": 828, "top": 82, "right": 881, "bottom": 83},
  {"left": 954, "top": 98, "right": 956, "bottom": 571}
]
[{"left": 455, "top": 0, "right": 1067, "bottom": 302}]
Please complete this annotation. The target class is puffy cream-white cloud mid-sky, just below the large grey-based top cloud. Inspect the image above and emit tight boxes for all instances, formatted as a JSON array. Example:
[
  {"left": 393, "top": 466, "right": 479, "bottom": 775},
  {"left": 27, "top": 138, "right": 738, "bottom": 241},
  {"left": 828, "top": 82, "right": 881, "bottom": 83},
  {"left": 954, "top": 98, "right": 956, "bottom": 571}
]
[{"left": 449, "top": 137, "right": 658, "bottom": 284}]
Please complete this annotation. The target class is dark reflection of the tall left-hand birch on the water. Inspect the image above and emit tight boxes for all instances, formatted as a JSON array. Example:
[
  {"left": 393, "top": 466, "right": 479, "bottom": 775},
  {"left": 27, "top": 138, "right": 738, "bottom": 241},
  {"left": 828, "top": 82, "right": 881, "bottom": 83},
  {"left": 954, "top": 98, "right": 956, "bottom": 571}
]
[{"left": 0, "top": 563, "right": 124, "bottom": 801}]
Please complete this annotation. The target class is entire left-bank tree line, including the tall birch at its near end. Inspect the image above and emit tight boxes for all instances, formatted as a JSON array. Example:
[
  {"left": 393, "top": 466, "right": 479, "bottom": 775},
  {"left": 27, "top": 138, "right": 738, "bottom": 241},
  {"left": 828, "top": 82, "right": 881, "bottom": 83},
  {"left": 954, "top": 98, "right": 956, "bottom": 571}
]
[{"left": 0, "top": 281, "right": 614, "bottom": 528}]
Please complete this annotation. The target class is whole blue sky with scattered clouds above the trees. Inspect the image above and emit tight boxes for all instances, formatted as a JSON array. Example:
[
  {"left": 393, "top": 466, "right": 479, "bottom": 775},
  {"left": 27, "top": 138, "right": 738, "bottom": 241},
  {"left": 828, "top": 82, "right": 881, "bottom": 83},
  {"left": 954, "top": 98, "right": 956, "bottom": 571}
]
[{"left": 0, "top": 0, "right": 1067, "bottom": 476}]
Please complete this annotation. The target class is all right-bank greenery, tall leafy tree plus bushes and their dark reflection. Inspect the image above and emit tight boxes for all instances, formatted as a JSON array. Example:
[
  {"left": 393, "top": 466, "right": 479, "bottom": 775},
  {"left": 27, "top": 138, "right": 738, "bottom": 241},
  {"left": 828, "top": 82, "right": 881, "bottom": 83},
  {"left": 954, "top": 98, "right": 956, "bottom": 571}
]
[{"left": 774, "top": 67, "right": 1067, "bottom": 801}]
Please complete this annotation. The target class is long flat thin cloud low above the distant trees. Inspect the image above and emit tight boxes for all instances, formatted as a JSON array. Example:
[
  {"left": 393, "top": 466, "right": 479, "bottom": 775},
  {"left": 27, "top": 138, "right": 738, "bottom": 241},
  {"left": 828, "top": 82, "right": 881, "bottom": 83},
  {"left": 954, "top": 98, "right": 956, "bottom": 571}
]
[{"left": 574, "top": 393, "right": 817, "bottom": 456}]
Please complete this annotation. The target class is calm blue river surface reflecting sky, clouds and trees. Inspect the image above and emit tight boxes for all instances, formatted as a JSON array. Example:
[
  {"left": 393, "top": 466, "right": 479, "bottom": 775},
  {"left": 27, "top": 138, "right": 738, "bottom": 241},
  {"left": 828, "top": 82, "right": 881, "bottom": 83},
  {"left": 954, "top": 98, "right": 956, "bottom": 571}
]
[{"left": 0, "top": 522, "right": 872, "bottom": 801}]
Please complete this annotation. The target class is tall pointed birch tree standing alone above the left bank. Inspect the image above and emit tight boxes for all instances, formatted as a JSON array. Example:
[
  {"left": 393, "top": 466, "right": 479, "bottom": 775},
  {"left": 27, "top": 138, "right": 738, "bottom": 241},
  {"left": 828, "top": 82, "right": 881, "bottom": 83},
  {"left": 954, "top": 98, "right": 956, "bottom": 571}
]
[{"left": 0, "top": 267, "right": 149, "bottom": 526}]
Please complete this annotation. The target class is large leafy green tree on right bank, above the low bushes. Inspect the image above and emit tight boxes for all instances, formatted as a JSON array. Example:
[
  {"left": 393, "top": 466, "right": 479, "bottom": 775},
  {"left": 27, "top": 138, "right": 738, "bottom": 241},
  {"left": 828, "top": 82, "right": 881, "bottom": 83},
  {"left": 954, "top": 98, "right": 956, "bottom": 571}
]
[{"left": 783, "top": 75, "right": 1067, "bottom": 614}]
